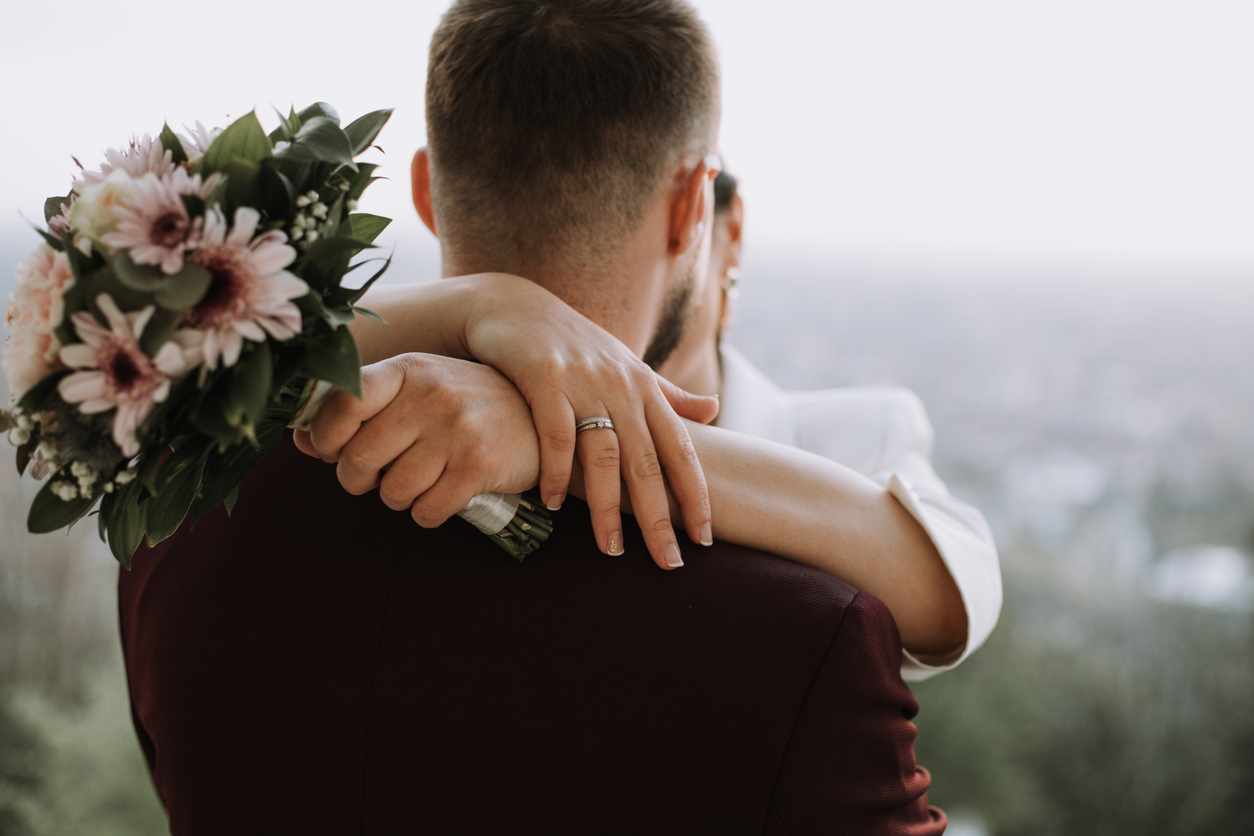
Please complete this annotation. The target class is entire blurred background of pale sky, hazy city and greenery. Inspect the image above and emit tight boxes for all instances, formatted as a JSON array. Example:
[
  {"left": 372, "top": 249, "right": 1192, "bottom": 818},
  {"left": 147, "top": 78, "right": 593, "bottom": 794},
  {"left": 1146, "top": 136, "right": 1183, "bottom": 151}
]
[{"left": 0, "top": 0, "right": 1254, "bottom": 836}]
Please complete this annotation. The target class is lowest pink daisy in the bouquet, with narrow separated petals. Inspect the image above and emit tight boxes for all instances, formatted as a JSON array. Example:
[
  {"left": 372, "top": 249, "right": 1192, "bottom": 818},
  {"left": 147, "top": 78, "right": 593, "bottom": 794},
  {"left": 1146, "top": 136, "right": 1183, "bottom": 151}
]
[{"left": 56, "top": 293, "right": 187, "bottom": 456}]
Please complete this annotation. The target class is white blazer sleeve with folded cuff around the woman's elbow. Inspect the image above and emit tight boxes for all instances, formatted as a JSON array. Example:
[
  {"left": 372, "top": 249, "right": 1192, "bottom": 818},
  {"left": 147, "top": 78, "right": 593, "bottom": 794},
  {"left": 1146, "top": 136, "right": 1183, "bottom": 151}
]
[{"left": 795, "top": 387, "right": 1002, "bottom": 682}]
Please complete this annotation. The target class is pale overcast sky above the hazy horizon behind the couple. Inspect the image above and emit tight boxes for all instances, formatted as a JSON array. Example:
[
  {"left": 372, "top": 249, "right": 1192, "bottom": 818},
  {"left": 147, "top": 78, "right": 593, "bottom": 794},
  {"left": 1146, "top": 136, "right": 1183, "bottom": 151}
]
[{"left": 0, "top": 0, "right": 1254, "bottom": 284}]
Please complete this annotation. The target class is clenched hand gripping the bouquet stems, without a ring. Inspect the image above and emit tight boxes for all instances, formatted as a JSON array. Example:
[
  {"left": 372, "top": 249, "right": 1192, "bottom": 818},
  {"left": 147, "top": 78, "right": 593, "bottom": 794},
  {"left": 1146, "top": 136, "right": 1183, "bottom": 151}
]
[{"left": 295, "top": 353, "right": 540, "bottom": 528}]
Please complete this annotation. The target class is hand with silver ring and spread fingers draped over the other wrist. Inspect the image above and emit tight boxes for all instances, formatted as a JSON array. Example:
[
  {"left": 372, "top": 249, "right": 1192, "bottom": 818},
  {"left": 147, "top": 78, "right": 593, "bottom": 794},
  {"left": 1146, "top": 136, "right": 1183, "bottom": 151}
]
[{"left": 464, "top": 273, "right": 719, "bottom": 568}]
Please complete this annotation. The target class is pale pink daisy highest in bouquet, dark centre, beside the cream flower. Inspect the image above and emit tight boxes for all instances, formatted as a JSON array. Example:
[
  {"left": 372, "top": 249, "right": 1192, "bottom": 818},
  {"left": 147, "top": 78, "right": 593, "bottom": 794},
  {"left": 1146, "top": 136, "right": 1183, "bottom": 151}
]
[{"left": 100, "top": 168, "right": 217, "bottom": 276}]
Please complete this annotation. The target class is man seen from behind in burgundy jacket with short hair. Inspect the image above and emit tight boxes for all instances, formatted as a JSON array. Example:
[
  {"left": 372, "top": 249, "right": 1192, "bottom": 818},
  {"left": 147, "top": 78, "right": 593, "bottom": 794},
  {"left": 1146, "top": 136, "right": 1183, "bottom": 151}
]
[{"left": 119, "top": 0, "right": 944, "bottom": 835}]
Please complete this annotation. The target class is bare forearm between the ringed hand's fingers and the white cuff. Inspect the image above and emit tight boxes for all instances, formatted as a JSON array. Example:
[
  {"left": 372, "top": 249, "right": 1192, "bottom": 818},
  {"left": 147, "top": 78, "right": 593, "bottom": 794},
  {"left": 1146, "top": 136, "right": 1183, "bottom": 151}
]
[{"left": 688, "top": 424, "right": 967, "bottom": 654}]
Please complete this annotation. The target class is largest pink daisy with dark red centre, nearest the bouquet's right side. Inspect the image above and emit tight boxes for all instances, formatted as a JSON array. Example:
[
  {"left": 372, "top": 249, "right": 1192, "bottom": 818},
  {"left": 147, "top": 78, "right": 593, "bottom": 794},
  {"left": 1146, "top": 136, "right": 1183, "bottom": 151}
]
[{"left": 183, "top": 207, "right": 310, "bottom": 375}]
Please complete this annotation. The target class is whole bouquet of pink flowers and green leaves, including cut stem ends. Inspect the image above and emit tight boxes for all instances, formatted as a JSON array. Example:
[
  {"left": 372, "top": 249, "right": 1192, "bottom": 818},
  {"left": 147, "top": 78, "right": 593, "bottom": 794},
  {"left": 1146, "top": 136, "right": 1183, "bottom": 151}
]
[{"left": 0, "top": 103, "right": 552, "bottom": 567}]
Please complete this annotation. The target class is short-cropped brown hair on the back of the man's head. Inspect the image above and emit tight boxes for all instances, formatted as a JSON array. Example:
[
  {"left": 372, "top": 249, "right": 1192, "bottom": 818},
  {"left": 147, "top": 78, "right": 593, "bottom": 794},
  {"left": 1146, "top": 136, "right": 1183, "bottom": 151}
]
[{"left": 426, "top": 0, "right": 719, "bottom": 263}]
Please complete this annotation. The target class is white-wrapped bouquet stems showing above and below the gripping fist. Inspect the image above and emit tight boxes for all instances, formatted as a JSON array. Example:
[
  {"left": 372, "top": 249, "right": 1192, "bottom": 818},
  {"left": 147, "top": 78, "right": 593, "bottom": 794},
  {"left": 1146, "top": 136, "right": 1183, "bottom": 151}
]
[{"left": 287, "top": 380, "right": 553, "bottom": 563}]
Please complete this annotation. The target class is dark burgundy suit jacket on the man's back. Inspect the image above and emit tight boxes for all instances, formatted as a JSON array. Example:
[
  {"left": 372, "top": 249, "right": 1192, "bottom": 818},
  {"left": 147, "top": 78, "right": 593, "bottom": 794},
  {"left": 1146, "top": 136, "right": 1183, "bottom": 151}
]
[{"left": 119, "top": 439, "right": 946, "bottom": 836}]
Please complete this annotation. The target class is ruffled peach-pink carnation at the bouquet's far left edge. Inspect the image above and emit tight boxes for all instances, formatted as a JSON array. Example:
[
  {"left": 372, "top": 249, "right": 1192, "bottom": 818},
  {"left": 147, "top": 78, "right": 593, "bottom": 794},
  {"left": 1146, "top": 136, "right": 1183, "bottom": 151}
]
[{"left": 4, "top": 244, "right": 74, "bottom": 402}]
